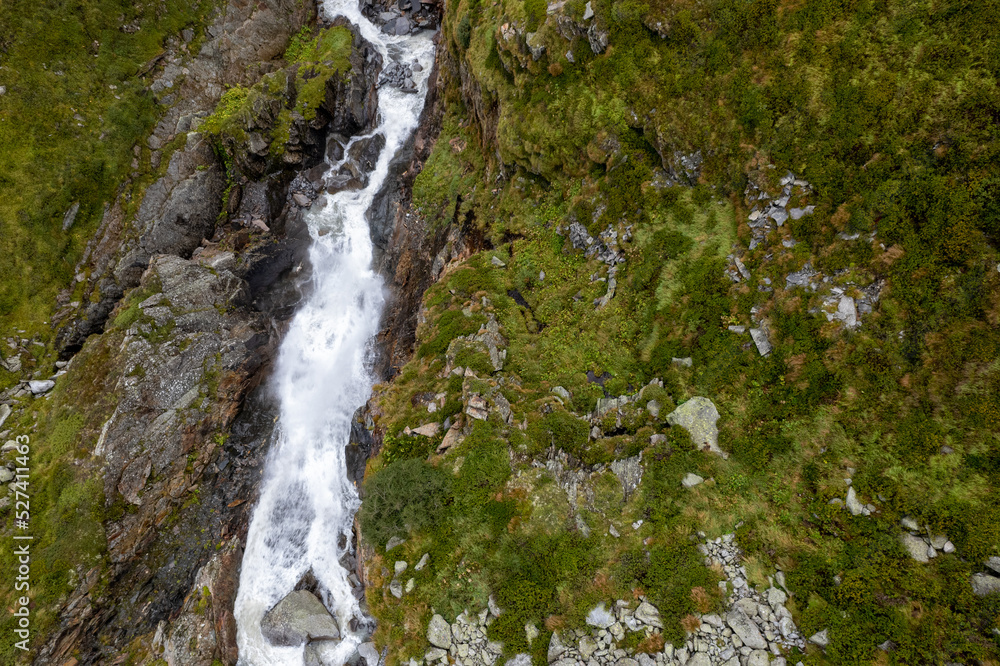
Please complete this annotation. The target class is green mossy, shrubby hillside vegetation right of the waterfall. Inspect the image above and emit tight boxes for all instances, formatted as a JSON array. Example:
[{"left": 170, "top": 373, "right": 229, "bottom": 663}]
[{"left": 369, "top": 0, "right": 1000, "bottom": 664}]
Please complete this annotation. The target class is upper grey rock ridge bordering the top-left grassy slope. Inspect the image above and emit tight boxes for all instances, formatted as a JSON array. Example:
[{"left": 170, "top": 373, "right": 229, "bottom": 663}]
[{"left": 56, "top": 0, "right": 315, "bottom": 358}]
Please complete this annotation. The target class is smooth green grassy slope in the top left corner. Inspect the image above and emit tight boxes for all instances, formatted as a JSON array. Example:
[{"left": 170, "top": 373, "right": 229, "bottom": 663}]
[{"left": 0, "top": 0, "right": 216, "bottom": 337}]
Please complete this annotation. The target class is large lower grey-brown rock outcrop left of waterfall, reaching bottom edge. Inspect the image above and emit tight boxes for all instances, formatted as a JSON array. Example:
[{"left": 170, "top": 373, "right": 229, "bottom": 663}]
[{"left": 38, "top": 251, "right": 276, "bottom": 664}]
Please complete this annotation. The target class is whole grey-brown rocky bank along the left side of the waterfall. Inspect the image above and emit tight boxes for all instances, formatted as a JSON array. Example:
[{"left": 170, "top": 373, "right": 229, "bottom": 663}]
[{"left": 4, "top": 2, "right": 446, "bottom": 664}]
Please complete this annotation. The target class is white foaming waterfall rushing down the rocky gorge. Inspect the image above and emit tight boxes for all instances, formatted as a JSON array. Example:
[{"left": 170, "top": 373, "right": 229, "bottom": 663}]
[{"left": 235, "top": 0, "right": 434, "bottom": 666}]
